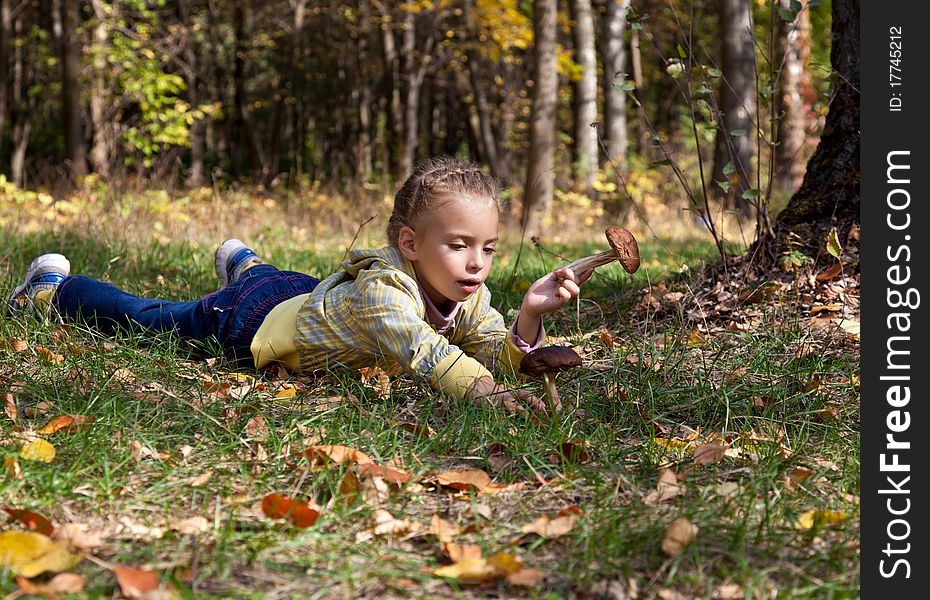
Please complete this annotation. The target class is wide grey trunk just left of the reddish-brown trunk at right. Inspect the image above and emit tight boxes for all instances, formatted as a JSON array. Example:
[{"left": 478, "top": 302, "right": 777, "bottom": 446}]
[{"left": 711, "top": 0, "right": 756, "bottom": 216}]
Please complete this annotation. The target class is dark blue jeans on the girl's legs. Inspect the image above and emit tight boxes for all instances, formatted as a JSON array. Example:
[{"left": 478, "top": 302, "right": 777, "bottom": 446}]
[{"left": 53, "top": 264, "right": 320, "bottom": 367}]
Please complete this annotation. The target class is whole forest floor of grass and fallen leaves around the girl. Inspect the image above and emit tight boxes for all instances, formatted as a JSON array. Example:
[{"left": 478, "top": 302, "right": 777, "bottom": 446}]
[{"left": 0, "top": 186, "right": 860, "bottom": 599}]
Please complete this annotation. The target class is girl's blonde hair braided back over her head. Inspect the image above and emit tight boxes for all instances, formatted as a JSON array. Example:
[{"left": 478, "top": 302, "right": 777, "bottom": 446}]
[{"left": 387, "top": 156, "right": 503, "bottom": 248}]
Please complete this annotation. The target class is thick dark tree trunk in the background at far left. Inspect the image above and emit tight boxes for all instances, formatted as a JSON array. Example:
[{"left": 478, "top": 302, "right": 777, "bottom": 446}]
[{"left": 56, "top": 0, "right": 87, "bottom": 177}]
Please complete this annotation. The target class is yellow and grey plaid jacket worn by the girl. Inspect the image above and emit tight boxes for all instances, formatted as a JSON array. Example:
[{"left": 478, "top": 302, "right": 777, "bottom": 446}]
[{"left": 294, "top": 247, "right": 544, "bottom": 398}]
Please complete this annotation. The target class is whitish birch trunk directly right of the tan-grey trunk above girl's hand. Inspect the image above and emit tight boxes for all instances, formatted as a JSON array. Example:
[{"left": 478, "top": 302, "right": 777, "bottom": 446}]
[{"left": 572, "top": 0, "right": 600, "bottom": 194}]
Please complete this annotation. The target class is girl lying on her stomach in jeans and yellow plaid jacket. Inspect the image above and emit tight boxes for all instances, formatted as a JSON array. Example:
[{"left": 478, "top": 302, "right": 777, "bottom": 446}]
[{"left": 10, "top": 158, "right": 591, "bottom": 411}]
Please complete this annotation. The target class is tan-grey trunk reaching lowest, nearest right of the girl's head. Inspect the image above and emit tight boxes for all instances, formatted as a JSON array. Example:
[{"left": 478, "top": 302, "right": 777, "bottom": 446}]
[{"left": 522, "top": 0, "right": 559, "bottom": 237}]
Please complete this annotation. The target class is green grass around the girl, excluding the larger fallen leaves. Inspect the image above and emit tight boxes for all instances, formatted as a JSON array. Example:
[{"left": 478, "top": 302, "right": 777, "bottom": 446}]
[{"left": 0, "top": 195, "right": 859, "bottom": 598}]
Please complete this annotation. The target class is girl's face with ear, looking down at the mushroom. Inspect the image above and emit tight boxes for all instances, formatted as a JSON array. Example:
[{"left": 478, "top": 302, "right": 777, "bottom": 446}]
[{"left": 398, "top": 197, "right": 498, "bottom": 309}]
